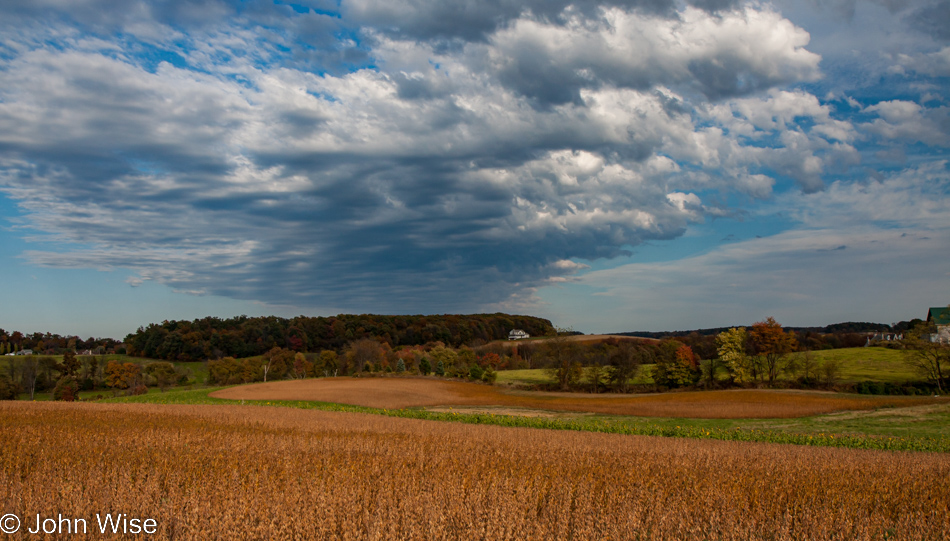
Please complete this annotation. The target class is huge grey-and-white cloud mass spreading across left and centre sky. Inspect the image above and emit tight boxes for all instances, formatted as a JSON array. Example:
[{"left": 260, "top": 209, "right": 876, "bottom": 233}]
[{"left": 0, "top": 1, "right": 939, "bottom": 311}]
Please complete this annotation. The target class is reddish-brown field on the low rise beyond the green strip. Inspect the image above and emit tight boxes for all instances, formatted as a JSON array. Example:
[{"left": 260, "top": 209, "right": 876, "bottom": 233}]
[{"left": 211, "top": 378, "right": 942, "bottom": 419}]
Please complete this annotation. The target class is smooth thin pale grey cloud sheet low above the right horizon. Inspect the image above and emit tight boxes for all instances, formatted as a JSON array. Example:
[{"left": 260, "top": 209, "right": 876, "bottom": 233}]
[{"left": 575, "top": 162, "right": 950, "bottom": 330}]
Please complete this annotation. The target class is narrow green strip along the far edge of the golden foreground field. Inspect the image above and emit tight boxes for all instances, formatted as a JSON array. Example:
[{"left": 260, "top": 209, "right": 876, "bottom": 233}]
[{"left": 101, "top": 387, "right": 950, "bottom": 453}]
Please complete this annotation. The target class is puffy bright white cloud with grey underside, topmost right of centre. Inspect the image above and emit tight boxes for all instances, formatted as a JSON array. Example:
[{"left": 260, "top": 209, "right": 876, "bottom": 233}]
[{"left": 491, "top": 8, "right": 819, "bottom": 104}]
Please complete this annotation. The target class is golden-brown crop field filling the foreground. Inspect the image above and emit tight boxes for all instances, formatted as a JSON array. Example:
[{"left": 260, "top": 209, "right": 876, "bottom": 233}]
[{"left": 0, "top": 402, "right": 950, "bottom": 540}]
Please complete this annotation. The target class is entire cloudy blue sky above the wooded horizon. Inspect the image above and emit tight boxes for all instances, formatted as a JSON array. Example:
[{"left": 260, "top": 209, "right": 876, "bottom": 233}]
[{"left": 0, "top": 0, "right": 950, "bottom": 338}]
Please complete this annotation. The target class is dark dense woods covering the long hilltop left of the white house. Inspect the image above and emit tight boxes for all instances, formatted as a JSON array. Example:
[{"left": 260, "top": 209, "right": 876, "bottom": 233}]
[{"left": 125, "top": 313, "right": 554, "bottom": 361}]
